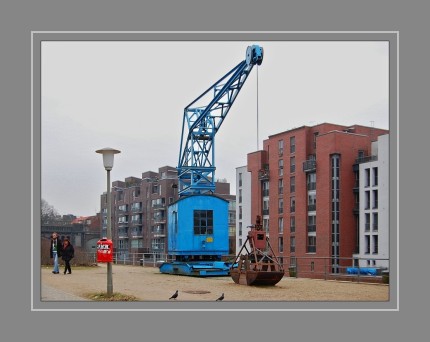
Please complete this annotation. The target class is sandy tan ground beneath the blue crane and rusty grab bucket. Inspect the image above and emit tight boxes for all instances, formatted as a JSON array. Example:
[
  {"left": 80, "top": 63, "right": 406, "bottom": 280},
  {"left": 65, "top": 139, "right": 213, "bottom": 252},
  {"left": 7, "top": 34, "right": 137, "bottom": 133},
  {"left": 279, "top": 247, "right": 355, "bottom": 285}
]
[{"left": 41, "top": 264, "right": 389, "bottom": 302}]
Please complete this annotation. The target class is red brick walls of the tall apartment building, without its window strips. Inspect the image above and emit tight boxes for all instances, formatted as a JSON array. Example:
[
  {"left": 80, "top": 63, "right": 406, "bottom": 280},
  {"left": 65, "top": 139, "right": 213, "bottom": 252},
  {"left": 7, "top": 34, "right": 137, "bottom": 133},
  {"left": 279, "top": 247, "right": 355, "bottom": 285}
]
[{"left": 248, "top": 123, "right": 388, "bottom": 273}]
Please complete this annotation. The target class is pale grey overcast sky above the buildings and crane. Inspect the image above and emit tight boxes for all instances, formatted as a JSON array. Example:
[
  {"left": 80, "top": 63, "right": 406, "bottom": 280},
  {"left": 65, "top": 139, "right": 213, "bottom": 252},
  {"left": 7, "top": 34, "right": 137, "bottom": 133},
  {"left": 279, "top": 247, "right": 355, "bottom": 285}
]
[{"left": 41, "top": 41, "right": 389, "bottom": 216}]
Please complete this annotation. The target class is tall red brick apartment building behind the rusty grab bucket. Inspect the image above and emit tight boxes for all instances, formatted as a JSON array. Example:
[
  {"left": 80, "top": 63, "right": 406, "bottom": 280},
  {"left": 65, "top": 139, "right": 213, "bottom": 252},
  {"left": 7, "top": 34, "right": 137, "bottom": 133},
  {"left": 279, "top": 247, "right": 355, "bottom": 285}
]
[{"left": 247, "top": 123, "right": 388, "bottom": 278}]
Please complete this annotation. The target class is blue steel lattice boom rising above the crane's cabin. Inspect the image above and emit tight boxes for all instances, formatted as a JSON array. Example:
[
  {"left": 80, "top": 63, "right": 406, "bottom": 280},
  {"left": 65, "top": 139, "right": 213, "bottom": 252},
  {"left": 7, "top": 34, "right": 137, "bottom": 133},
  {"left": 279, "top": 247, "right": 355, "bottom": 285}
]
[{"left": 177, "top": 45, "right": 263, "bottom": 196}]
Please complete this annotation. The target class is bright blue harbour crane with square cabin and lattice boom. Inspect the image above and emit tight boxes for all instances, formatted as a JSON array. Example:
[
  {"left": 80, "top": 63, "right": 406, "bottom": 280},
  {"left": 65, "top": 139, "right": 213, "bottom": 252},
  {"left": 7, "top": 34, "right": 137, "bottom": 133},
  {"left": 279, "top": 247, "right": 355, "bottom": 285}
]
[{"left": 160, "top": 45, "right": 263, "bottom": 277}]
